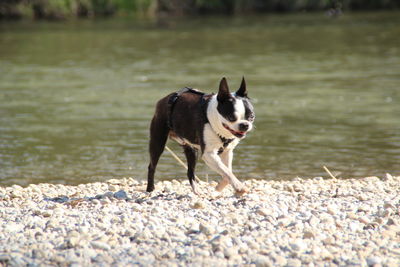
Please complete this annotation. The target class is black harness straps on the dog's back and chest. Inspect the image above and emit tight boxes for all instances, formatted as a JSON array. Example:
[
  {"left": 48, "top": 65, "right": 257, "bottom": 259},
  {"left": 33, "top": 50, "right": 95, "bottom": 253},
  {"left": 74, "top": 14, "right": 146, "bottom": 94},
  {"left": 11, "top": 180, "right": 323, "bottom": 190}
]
[{"left": 168, "top": 87, "right": 234, "bottom": 155}]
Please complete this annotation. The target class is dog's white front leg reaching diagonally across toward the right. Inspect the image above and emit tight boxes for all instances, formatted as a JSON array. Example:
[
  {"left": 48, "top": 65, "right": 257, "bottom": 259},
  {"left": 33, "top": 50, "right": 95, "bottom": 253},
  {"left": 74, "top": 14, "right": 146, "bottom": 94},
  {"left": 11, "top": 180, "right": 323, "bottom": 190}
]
[{"left": 203, "top": 151, "right": 247, "bottom": 194}]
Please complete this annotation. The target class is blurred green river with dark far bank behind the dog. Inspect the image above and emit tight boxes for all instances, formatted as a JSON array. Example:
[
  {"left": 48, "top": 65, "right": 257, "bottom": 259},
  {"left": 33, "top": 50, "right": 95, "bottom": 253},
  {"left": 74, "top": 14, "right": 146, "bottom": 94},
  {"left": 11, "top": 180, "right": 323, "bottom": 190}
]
[{"left": 0, "top": 0, "right": 400, "bottom": 185}]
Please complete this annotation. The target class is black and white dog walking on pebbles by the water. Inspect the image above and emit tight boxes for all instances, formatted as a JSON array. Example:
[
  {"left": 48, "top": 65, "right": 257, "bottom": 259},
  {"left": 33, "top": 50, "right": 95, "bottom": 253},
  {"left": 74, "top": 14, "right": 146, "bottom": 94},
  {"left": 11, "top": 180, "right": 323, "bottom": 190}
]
[{"left": 147, "top": 78, "right": 255, "bottom": 195}]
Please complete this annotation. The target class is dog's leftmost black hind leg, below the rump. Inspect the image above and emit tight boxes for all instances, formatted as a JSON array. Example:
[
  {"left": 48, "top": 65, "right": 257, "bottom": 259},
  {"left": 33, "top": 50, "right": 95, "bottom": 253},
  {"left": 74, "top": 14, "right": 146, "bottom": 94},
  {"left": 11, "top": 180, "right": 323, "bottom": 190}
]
[{"left": 146, "top": 114, "right": 169, "bottom": 192}]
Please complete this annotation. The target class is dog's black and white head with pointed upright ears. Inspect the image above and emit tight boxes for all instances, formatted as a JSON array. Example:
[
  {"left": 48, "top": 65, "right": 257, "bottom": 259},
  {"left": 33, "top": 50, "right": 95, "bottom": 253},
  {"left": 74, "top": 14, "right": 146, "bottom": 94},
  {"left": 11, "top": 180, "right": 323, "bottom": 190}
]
[{"left": 217, "top": 77, "right": 255, "bottom": 138}]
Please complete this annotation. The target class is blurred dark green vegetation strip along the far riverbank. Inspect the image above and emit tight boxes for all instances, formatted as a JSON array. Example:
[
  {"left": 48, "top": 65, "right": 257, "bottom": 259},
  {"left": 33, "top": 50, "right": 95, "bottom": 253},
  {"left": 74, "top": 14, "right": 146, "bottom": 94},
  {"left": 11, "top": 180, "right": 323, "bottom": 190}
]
[{"left": 0, "top": 0, "right": 400, "bottom": 19}]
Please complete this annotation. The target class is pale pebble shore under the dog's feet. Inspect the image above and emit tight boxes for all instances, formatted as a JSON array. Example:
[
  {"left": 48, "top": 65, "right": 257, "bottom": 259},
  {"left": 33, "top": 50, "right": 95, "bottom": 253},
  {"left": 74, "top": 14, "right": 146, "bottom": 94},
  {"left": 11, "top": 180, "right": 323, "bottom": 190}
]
[{"left": 0, "top": 174, "right": 400, "bottom": 266}]
